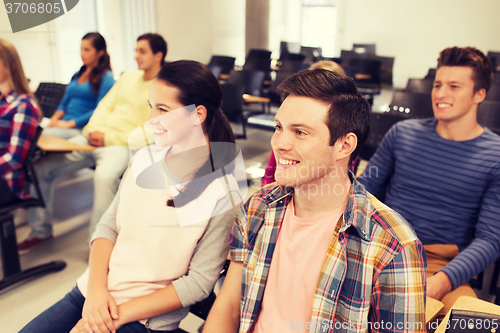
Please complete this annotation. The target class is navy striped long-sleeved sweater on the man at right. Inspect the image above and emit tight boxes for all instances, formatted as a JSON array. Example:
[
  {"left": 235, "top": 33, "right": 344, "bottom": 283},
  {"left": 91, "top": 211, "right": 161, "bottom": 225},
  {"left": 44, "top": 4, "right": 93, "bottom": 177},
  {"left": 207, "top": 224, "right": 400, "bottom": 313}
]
[{"left": 359, "top": 119, "right": 500, "bottom": 288}]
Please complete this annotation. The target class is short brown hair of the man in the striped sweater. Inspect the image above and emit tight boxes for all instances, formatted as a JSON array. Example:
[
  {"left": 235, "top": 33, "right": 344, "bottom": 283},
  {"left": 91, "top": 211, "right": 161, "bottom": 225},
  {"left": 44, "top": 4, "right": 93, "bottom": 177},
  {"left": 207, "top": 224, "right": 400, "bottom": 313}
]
[{"left": 437, "top": 46, "right": 493, "bottom": 93}]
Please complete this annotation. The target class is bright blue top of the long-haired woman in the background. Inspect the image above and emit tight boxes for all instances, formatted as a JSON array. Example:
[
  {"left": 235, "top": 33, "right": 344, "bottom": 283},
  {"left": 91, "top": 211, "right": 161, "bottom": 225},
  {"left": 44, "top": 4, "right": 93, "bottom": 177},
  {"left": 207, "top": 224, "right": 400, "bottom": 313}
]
[{"left": 57, "top": 71, "right": 115, "bottom": 128}]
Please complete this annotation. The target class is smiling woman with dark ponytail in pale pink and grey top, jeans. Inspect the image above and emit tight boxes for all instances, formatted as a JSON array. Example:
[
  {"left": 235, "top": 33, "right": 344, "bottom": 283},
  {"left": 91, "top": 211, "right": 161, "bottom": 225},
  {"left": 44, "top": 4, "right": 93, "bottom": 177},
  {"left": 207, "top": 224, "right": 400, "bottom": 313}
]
[{"left": 20, "top": 61, "right": 241, "bottom": 333}]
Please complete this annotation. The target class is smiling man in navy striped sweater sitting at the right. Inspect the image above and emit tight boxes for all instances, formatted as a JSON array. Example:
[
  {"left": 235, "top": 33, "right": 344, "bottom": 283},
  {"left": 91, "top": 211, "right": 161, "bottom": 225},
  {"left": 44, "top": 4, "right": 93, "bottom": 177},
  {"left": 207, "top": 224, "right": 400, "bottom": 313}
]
[{"left": 359, "top": 47, "right": 500, "bottom": 315}]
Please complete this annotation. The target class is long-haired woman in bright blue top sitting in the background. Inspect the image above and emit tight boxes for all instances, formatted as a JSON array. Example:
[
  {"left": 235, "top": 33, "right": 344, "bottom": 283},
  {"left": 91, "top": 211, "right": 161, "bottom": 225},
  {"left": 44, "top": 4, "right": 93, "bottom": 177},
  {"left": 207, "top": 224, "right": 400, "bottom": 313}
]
[{"left": 43, "top": 32, "right": 115, "bottom": 139}]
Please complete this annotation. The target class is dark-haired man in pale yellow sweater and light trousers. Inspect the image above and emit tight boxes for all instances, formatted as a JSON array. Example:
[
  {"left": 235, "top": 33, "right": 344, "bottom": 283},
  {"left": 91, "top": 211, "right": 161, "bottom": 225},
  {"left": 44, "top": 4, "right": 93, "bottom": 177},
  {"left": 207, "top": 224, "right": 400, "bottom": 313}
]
[{"left": 18, "top": 33, "right": 167, "bottom": 252}]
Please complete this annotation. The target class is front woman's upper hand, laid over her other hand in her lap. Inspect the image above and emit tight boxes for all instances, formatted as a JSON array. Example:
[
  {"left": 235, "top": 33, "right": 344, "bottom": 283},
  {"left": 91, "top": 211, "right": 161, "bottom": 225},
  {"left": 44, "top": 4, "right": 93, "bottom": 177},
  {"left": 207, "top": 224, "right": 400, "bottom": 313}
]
[{"left": 80, "top": 288, "right": 118, "bottom": 333}]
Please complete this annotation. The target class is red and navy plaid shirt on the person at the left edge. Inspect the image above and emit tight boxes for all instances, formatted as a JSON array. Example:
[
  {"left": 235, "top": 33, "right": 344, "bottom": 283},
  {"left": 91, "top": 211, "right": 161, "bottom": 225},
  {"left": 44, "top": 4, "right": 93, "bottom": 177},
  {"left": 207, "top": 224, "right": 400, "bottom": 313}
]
[{"left": 0, "top": 92, "right": 41, "bottom": 199}]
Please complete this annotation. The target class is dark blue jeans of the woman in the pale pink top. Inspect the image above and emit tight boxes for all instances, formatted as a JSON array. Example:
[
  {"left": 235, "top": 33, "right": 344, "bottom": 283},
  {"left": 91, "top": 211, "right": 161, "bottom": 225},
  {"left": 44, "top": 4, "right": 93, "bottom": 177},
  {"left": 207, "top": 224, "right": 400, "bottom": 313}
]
[{"left": 19, "top": 287, "right": 176, "bottom": 333}]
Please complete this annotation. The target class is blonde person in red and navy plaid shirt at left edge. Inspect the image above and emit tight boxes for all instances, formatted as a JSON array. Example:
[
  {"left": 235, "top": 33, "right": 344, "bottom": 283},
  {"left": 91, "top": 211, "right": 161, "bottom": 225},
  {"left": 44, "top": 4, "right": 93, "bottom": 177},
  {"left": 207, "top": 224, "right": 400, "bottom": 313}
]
[{"left": 0, "top": 39, "right": 41, "bottom": 206}]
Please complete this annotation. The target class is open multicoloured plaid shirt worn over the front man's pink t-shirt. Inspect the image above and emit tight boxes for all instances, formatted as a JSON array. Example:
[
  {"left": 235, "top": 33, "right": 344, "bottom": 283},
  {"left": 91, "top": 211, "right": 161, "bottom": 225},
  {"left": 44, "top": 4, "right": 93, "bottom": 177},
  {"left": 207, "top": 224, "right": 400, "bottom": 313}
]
[{"left": 230, "top": 173, "right": 426, "bottom": 332}]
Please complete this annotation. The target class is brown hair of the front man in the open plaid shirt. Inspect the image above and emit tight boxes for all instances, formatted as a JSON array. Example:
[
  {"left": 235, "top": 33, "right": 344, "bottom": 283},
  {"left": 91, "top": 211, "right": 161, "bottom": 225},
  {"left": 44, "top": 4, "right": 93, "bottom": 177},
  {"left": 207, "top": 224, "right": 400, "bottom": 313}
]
[{"left": 278, "top": 69, "right": 370, "bottom": 161}]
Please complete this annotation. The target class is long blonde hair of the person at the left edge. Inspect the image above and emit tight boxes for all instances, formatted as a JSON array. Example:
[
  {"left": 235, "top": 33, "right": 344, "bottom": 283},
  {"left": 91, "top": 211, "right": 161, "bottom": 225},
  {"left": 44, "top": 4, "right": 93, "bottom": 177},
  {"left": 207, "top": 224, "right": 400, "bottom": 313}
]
[{"left": 0, "top": 39, "right": 36, "bottom": 101}]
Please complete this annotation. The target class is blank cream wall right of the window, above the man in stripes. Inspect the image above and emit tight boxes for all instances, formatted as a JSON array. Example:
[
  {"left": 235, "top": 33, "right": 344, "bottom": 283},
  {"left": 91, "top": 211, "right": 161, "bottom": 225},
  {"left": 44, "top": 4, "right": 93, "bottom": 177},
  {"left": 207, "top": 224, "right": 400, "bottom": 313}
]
[{"left": 340, "top": 0, "right": 500, "bottom": 87}]
